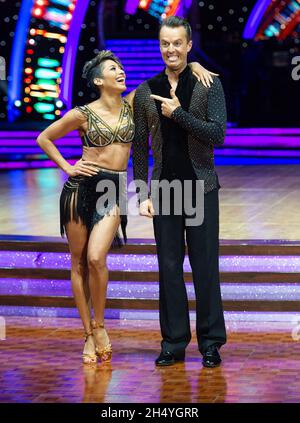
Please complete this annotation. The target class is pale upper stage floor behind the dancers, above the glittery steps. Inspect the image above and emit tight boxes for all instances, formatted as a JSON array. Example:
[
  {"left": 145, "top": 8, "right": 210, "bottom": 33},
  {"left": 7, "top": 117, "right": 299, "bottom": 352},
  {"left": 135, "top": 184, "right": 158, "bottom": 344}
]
[{"left": 0, "top": 165, "right": 300, "bottom": 240}]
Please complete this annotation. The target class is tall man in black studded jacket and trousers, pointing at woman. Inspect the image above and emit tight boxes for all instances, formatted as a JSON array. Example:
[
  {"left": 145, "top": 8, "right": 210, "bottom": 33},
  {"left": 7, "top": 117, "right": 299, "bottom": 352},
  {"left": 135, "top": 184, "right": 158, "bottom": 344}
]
[{"left": 133, "top": 16, "right": 226, "bottom": 367}]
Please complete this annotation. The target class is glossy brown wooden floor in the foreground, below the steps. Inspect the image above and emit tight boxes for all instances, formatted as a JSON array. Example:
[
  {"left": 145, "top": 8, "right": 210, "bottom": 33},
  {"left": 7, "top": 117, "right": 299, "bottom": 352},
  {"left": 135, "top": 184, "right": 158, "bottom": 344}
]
[{"left": 0, "top": 317, "right": 300, "bottom": 403}]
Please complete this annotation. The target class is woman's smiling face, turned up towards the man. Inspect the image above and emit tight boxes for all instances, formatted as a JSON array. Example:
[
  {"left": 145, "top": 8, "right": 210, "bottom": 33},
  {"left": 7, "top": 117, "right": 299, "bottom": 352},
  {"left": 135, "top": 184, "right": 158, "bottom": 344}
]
[{"left": 96, "top": 60, "right": 126, "bottom": 93}]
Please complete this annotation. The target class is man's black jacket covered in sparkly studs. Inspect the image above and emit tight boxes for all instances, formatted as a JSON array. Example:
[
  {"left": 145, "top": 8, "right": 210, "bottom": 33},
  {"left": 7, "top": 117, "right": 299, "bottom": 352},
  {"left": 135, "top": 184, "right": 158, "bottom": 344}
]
[{"left": 132, "top": 73, "right": 226, "bottom": 201}]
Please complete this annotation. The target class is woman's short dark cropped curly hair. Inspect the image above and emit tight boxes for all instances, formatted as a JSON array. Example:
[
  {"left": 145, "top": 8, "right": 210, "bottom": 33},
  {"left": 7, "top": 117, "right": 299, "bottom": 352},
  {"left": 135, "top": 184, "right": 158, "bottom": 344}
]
[{"left": 82, "top": 50, "right": 123, "bottom": 94}]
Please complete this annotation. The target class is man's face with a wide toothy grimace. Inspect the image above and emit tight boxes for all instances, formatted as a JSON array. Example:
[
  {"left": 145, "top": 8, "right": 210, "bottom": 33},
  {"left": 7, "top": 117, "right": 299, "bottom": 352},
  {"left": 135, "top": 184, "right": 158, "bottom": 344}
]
[{"left": 159, "top": 26, "right": 192, "bottom": 71}]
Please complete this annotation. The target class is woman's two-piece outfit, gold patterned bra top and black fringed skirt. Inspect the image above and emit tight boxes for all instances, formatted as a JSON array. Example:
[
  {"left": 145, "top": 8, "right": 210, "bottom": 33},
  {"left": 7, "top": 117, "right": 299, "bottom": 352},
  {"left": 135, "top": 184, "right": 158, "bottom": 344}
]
[{"left": 60, "top": 100, "right": 134, "bottom": 246}]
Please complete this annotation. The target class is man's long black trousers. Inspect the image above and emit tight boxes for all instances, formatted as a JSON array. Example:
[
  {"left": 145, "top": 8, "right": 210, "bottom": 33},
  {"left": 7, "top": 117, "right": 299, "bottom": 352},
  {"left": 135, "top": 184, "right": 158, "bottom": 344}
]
[{"left": 153, "top": 189, "right": 226, "bottom": 353}]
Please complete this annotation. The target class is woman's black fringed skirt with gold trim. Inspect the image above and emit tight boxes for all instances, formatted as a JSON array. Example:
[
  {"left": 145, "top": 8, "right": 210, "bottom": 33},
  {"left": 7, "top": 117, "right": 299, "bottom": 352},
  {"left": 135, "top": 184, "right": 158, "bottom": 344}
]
[{"left": 60, "top": 166, "right": 127, "bottom": 247}]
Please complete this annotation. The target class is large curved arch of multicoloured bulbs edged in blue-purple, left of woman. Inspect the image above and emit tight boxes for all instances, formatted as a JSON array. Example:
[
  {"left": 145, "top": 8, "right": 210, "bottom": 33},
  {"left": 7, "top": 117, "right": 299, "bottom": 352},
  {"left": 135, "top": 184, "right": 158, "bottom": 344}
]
[{"left": 8, "top": 0, "right": 89, "bottom": 122}]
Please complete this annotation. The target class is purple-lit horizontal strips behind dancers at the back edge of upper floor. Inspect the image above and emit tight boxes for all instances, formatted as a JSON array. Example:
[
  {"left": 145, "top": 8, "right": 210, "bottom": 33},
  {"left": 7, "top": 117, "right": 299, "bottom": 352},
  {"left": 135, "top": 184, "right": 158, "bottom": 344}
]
[{"left": 0, "top": 127, "right": 300, "bottom": 169}]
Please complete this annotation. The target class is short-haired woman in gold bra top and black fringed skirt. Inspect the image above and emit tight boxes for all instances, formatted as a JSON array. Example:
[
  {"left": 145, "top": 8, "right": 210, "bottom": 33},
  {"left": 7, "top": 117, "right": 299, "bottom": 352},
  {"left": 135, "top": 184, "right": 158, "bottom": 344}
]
[{"left": 37, "top": 51, "right": 214, "bottom": 363}]
